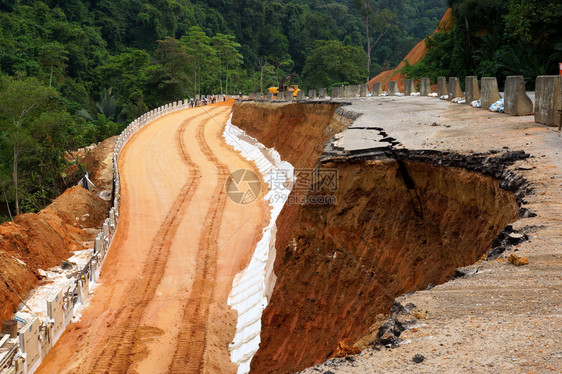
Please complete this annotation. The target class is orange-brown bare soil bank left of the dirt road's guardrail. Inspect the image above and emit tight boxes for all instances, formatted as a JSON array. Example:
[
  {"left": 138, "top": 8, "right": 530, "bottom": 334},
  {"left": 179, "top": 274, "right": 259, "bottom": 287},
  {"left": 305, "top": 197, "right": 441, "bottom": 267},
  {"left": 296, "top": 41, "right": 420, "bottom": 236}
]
[{"left": 0, "top": 186, "right": 109, "bottom": 320}]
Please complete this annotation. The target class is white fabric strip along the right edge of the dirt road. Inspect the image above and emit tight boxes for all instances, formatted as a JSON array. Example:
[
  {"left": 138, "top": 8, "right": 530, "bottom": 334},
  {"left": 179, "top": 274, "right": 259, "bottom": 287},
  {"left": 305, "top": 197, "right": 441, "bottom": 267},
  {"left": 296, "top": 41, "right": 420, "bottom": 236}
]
[{"left": 223, "top": 117, "right": 294, "bottom": 374}]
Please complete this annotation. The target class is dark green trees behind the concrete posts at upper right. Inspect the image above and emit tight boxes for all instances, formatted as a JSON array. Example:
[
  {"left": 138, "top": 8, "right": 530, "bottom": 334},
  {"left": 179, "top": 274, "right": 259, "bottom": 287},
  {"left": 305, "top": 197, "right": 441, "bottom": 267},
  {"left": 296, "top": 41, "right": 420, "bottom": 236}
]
[{"left": 403, "top": 0, "right": 562, "bottom": 89}]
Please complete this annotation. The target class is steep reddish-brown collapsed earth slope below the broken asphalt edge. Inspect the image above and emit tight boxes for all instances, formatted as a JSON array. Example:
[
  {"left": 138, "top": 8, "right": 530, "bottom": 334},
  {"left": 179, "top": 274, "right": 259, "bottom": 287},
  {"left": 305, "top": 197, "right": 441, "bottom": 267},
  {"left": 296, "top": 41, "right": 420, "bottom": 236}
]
[{"left": 233, "top": 103, "right": 518, "bottom": 373}]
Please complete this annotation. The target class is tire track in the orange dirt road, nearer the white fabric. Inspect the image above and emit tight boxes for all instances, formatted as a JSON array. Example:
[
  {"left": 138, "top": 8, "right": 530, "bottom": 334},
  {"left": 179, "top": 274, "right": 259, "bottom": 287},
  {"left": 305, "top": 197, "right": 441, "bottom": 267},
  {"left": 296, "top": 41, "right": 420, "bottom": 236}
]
[{"left": 169, "top": 106, "right": 230, "bottom": 374}]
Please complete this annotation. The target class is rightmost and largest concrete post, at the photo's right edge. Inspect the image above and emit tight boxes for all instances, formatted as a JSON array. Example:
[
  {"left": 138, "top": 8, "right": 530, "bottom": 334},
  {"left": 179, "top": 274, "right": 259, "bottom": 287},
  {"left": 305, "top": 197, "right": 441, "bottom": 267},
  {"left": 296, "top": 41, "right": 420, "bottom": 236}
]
[{"left": 535, "top": 75, "right": 562, "bottom": 126}]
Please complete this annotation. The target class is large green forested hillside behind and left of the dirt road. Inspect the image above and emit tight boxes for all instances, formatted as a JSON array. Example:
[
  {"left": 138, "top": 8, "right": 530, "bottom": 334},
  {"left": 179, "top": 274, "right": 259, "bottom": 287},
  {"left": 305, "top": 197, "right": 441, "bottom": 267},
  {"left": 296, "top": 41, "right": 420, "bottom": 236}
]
[{"left": 0, "top": 0, "right": 446, "bottom": 221}]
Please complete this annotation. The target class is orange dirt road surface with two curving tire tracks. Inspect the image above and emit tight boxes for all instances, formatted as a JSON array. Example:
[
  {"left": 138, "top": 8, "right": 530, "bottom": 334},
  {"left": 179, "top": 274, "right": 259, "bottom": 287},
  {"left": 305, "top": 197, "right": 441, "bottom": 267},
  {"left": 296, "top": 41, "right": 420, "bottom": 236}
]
[{"left": 38, "top": 103, "right": 269, "bottom": 373}]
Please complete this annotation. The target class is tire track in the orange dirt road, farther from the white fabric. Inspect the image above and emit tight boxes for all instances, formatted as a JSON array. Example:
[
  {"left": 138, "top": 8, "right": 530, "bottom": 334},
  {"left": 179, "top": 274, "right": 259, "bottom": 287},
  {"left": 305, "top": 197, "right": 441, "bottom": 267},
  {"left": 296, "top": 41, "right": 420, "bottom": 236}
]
[{"left": 88, "top": 114, "right": 209, "bottom": 373}]
